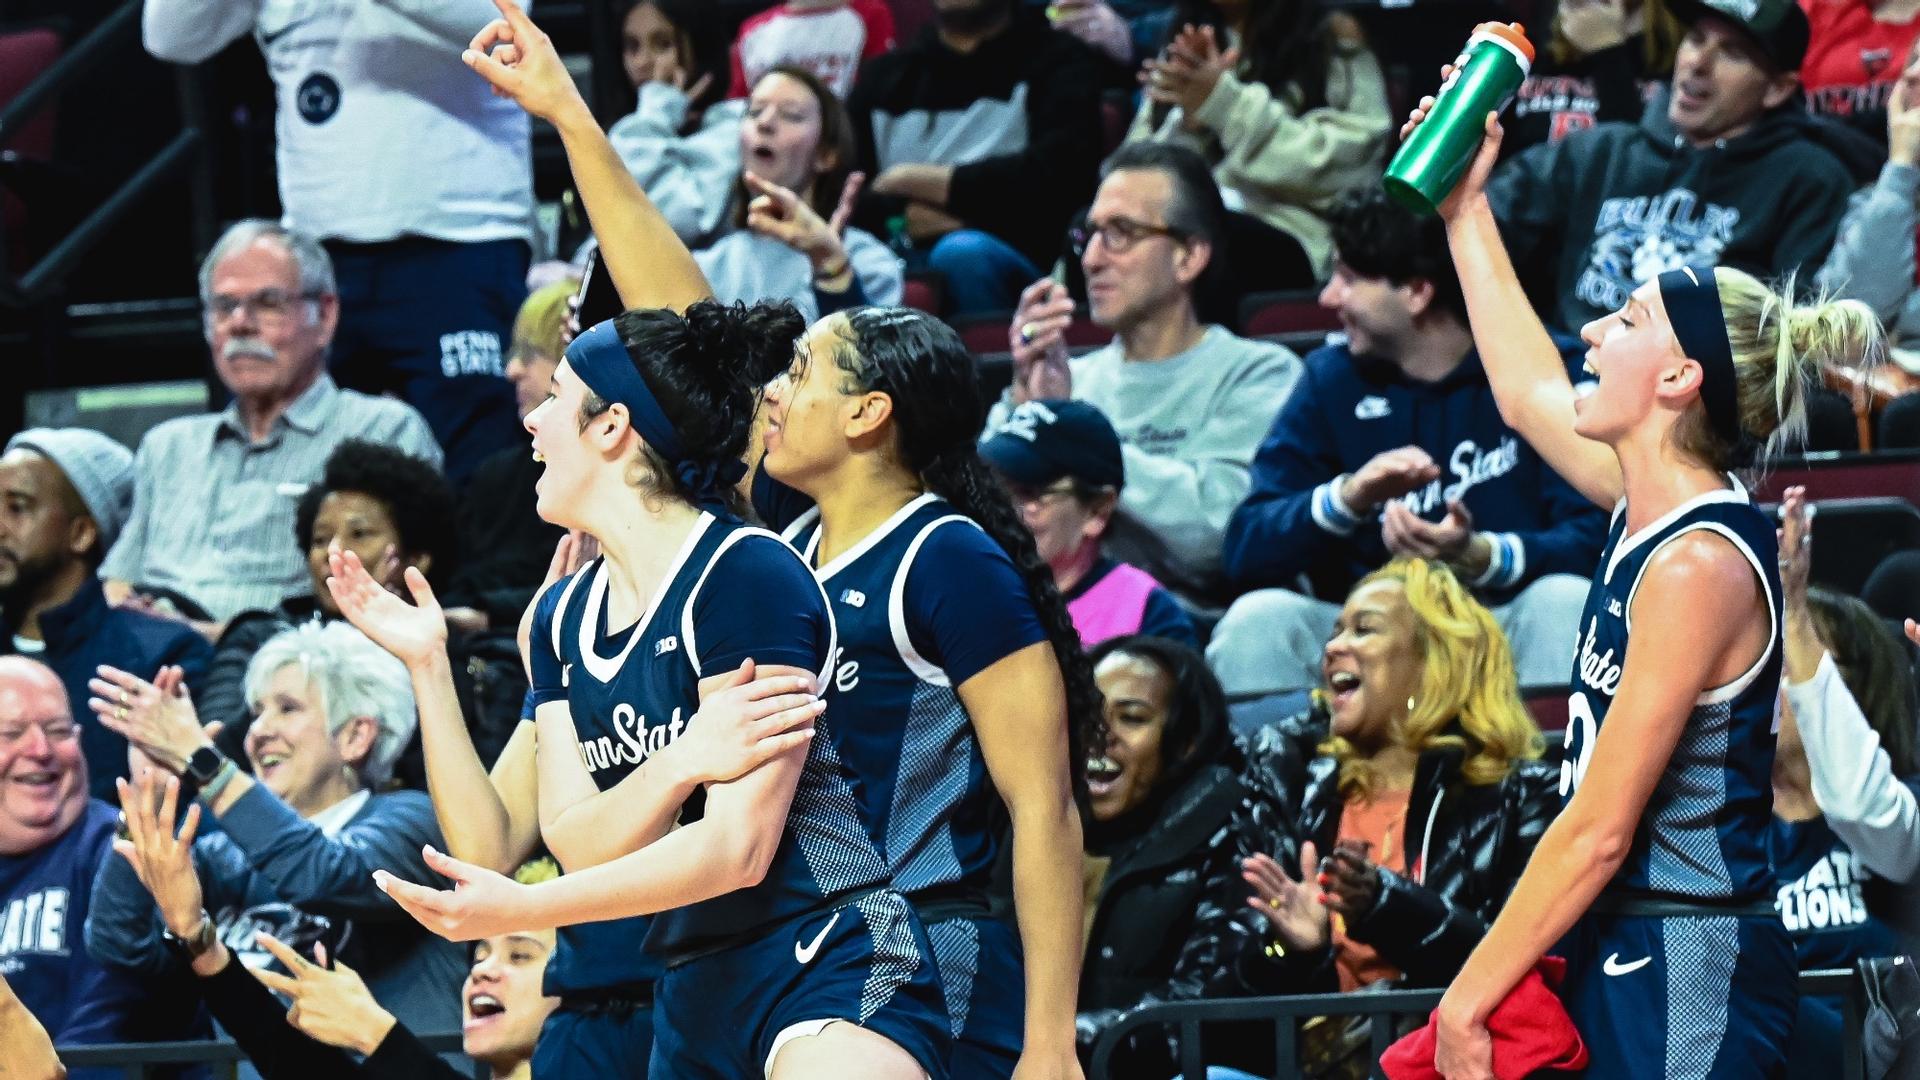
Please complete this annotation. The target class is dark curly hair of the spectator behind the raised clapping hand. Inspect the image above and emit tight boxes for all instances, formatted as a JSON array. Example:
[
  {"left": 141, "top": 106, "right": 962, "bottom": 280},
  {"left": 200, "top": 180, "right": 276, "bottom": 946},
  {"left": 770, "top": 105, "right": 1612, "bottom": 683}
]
[{"left": 294, "top": 438, "right": 457, "bottom": 582}]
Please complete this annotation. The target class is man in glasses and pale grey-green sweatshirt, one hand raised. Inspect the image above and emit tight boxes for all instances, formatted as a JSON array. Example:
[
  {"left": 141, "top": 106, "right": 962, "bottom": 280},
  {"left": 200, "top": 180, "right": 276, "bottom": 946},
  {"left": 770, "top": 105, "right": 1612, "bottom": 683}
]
[{"left": 987, "top": 142, "right": 1300, "bottom": 601}]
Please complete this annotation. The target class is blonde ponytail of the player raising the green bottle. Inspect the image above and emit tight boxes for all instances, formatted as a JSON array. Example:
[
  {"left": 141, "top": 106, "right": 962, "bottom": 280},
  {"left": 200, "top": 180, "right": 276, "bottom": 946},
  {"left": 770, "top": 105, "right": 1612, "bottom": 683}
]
[{"left": 1674, "top": 267, "right": 1885, "bottom": 469}]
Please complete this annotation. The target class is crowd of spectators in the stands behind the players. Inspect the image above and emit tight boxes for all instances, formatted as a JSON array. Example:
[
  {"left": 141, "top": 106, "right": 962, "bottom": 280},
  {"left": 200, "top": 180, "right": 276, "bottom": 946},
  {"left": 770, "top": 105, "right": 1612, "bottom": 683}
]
[{"left": 0, "top": 0, "right": 1920, "bottom": 1080}]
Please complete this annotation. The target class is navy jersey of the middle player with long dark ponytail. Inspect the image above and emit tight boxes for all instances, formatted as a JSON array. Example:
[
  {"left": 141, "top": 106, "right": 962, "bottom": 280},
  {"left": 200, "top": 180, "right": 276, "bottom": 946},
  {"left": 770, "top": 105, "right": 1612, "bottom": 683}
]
[{"left": 785, "top": 494, "right": 1046, "bottom": 894}]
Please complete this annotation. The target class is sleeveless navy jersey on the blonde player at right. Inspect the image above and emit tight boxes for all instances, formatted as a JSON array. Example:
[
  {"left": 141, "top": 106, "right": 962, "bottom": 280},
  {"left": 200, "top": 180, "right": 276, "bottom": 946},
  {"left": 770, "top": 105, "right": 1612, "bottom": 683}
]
[{"left": 1561, "top": 484, "right": 1780, "bottom": 901}]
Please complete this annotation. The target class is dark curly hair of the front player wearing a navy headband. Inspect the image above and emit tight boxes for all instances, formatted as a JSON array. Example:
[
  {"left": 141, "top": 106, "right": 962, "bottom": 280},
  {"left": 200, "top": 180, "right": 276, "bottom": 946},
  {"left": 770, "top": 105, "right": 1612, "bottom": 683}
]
[{"left": 580, "top": 300, "right": 806, "bottom": 517}]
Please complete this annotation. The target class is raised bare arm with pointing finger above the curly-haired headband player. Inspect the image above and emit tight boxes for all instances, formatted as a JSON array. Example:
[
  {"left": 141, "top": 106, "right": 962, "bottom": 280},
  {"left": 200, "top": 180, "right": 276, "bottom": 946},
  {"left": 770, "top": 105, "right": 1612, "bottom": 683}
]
[{"left": 461, "top": 0, "right": 712, "bottom": 311}]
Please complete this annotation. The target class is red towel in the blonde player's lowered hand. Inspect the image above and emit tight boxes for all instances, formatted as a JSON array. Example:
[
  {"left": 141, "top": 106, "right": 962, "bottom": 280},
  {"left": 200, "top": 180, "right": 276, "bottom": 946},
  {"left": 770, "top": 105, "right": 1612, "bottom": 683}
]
[{"left": 1380, "top": 957, "right": 1588, "bottom": 1080}]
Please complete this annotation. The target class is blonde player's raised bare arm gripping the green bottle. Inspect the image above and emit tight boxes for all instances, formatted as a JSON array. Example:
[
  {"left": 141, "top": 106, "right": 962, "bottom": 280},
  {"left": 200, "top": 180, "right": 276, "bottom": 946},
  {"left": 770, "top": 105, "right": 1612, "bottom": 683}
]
[{"left": 1402, "top": 99, "right": 1622, "bottom": 509}]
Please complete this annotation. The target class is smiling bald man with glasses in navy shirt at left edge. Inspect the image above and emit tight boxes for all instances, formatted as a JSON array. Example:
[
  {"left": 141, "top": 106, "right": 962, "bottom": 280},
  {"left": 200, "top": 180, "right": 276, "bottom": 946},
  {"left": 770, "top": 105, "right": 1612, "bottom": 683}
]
[{"left": 0, "top": 657, "right": 198, "bottom": 1078}]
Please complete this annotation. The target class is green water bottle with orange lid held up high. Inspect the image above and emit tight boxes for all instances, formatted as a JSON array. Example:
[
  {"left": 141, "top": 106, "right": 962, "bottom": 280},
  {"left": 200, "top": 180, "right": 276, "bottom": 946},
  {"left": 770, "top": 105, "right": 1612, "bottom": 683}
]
[{"left": 1384, "top": 23, "right": 1534, "bottom": 213}]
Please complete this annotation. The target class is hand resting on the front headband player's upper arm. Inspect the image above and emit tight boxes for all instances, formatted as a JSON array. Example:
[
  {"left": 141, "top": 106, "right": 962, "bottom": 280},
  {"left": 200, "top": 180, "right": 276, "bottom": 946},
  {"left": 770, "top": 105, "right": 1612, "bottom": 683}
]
[{"left": 666, "top": 659, "right": 828, "bottom": 784}]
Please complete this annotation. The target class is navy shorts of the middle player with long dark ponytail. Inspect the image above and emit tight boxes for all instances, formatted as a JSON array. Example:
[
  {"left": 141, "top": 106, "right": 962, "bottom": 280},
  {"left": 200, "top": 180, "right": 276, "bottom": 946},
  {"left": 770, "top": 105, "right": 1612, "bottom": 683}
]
[{"left": 927, "top": 917, "right": 1027, "bottom": 1080}]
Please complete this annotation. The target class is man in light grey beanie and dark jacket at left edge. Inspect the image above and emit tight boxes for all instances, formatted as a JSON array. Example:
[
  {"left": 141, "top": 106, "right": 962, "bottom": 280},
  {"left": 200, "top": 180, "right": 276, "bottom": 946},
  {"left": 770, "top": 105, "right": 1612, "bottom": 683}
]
[{"left": 0, "top": 429, "right": 213, "bottom": 799}]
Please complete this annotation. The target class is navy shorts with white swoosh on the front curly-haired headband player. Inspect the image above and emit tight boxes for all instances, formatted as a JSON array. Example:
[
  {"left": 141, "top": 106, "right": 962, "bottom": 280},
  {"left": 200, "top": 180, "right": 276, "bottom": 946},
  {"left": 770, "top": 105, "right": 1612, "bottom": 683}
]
[{"left": 651, "top": 892, "right": 952, "bottom": 1080}]
